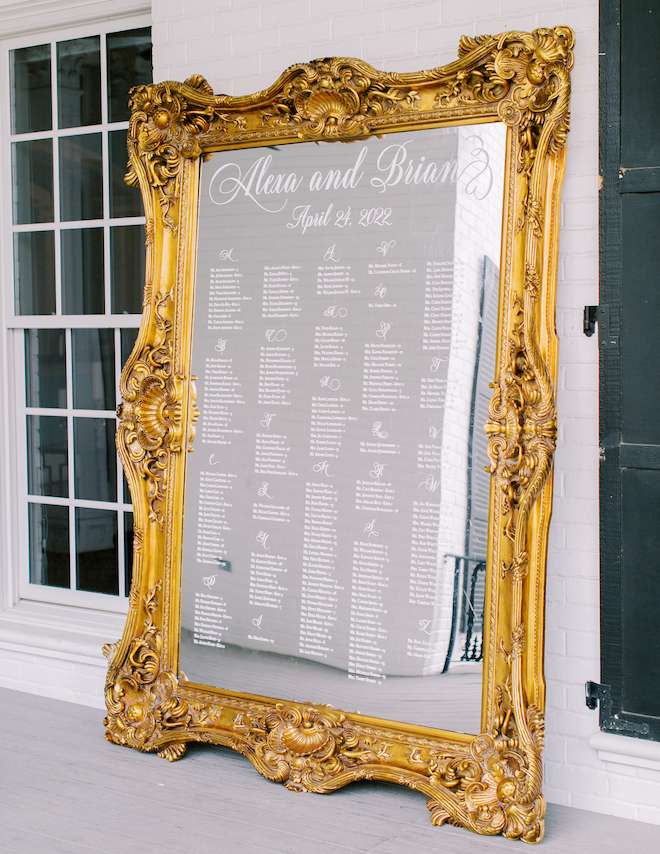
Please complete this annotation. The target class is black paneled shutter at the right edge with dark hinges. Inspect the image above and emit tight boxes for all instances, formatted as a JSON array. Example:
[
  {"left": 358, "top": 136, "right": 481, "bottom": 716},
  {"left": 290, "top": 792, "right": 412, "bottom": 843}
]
[{"left": 598, "top": 0, "right": 660, "bottom": 740}]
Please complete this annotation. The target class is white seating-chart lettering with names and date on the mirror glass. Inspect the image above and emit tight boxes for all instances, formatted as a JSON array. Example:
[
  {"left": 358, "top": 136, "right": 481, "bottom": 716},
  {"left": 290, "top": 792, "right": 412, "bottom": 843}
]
[{"left": 182, "top": 129, "right": 500, "bottom": 690}]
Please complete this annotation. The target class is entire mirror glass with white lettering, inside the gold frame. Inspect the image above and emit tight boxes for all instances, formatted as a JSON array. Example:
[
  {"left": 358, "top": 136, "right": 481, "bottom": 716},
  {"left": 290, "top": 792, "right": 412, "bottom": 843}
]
[{"left": 180, "top": 123, "right": 506, "bottom": 732}]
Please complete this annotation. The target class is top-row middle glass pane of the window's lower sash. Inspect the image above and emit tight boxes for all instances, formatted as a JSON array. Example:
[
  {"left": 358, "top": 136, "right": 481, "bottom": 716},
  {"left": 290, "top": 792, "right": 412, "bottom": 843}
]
[{"left": 71, "top": 329, "right": 116, "bottom": 412}]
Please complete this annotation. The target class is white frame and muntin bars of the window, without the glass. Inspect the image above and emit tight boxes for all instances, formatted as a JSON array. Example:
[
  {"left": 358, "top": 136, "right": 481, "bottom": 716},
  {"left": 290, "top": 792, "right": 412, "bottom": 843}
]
[{"left": 0, "top": 8, "right": 151, "bottom": 624}]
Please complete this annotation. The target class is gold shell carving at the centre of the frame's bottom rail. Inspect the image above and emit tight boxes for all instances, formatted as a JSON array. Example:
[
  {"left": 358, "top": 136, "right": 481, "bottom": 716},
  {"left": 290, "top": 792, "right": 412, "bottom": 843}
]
[{"left": 233, "top": 703, "right": 381, "bottom": 792}]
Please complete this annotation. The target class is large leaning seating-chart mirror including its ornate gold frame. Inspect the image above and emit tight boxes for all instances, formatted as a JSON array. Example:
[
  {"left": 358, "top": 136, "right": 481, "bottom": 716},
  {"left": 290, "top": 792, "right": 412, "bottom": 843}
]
[{"left": 106, "top": 27, "right": 573, "bottom": 842}]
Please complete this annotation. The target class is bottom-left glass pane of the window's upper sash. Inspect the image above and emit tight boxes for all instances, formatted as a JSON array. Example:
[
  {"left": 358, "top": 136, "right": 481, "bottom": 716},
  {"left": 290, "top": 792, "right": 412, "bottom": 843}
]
[{"left": 14, "top": 231, "right": 55, "bottom": 314}]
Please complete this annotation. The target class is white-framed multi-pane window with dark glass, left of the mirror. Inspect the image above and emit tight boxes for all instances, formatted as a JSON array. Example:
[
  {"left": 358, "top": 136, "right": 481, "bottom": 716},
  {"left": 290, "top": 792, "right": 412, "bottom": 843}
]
[{"left": 4, "top": 19, "right": 151, "bottom": 610}]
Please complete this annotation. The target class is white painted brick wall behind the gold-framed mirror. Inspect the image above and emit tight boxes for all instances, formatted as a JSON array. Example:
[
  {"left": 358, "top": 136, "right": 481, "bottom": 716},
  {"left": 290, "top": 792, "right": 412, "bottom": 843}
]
[{"left": 152, "top": 0, "right": 660, "bottom": 824}]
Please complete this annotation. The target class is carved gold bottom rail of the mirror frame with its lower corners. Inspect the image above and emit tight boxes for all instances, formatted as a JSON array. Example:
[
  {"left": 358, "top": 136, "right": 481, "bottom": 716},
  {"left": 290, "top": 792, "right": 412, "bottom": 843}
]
[{"left": 104, "top": 583, "right": 545, "bottom": 843}]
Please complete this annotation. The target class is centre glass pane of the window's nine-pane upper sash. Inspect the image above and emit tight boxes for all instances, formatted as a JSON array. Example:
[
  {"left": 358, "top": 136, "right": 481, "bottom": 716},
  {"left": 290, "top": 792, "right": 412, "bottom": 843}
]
[{"left": 60, "top": 133, "right": 103, "bottom": 222}]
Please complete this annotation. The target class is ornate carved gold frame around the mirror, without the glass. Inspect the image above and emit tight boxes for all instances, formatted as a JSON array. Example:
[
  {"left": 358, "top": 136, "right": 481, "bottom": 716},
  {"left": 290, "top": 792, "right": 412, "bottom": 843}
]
[{"left": 105, "top": 27, "right": 574, "bottom": 842}]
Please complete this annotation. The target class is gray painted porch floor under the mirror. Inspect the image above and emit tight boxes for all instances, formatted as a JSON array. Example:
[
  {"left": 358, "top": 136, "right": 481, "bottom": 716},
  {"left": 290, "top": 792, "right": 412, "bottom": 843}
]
[{"left": 0, "top": 689, "right": 660, "bottom": 854}]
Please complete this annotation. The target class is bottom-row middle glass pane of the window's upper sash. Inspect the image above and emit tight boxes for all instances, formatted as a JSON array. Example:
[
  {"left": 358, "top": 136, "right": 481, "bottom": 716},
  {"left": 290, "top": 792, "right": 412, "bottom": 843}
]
[{"left": 61, "top": 228, "right": 105, "bottom": 314}]
